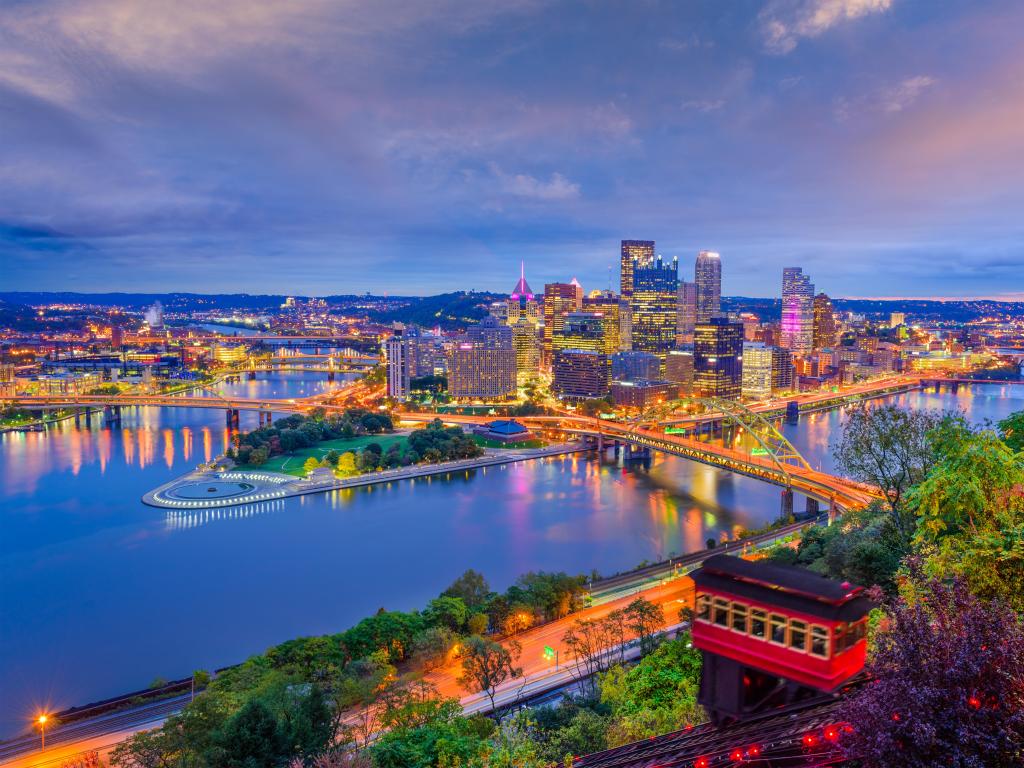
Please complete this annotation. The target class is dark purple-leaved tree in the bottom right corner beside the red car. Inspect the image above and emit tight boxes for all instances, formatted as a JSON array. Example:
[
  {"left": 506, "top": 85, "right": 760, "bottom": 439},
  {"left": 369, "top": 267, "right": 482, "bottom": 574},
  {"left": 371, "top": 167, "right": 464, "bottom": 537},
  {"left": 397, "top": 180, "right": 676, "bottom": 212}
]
[{"left": 840, "top": 562, "right": 1024, "bottom": 768}]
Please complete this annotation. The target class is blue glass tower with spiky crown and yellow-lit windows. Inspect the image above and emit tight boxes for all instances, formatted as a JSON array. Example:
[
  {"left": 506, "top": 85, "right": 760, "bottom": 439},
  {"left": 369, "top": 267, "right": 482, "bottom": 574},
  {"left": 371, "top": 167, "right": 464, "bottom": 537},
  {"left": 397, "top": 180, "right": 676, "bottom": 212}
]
[{"left": 630, "top": 256, "right": 679, "bottom": 360}]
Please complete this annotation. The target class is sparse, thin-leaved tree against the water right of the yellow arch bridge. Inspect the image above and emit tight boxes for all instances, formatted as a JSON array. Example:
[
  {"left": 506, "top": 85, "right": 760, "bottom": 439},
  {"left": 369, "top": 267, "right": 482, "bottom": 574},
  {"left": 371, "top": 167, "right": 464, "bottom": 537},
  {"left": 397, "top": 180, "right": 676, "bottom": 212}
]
[{"left": 833, "top": 406, "right": 942, "bottom": 546}]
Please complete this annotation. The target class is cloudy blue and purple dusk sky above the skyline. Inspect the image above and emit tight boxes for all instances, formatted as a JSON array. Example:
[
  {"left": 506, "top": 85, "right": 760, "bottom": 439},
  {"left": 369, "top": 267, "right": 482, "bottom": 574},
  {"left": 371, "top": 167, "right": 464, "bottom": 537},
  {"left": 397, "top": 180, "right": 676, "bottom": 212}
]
[{"left": 0, "top": 0, "right": 1024, "bottom": 299}]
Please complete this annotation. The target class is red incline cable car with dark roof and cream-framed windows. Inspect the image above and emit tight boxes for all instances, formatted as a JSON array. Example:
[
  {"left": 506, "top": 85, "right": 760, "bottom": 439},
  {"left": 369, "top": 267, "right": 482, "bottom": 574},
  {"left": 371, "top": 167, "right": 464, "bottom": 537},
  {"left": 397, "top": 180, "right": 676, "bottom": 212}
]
[{"left": 692, "top": 555, "right": 874, "bottom": 722}]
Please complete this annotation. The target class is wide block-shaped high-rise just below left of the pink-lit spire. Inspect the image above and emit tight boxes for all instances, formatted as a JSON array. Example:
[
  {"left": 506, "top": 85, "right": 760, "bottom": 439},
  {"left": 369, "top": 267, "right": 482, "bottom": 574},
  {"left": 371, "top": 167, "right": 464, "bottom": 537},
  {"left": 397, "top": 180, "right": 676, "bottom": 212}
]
[{"left": 447, "top": 316, "right": 516, "bottom": 400}]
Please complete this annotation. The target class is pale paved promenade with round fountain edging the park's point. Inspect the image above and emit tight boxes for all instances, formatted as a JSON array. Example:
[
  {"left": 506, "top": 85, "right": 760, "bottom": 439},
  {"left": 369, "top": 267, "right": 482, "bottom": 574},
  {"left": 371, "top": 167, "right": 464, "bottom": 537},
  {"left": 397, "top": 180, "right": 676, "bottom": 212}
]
[{"left": 142, "top": 442, "right": 590, "bottom": 509}]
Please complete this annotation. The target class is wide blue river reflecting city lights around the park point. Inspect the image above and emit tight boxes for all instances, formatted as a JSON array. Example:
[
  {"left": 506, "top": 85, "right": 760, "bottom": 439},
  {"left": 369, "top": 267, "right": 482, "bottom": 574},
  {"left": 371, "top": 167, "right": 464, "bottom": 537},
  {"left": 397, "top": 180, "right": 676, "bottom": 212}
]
[{"left": 0, "top": 374, "right": 1024, "bottom": 734}]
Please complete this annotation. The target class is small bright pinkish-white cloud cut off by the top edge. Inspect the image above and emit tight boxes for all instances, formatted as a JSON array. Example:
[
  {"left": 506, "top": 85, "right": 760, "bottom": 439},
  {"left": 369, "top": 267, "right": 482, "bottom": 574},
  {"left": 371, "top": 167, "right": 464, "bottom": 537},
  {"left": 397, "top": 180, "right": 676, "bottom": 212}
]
[{"left": 760, "top": 0, "right": 892, "bottom": 53}]
